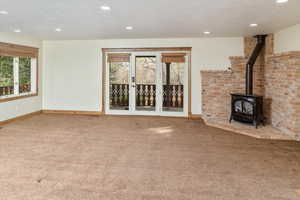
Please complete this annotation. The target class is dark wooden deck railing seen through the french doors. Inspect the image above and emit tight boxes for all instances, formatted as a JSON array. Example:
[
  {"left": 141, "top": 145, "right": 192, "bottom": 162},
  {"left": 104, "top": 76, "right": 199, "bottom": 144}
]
[{"left": 110, "top": 84, "right": 184, "bottom": 108}]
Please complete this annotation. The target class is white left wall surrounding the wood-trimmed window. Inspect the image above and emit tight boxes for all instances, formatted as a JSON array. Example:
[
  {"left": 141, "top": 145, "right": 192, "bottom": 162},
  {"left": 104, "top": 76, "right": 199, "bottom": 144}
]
[{"left": 0, "top": 33, "right": 42, "bottom": 121}]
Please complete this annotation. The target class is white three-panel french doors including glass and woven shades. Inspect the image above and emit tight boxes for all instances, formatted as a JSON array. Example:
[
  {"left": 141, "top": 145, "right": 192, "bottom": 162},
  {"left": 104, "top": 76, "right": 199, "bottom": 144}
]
[{"left": 105, "top": 52, "right": 188, "bottom": 116}]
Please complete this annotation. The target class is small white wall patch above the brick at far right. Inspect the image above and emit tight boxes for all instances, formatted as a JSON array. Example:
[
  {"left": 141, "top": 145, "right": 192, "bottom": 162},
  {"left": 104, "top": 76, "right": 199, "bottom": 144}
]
[{"left": 274, "top": 24, "right": 300, "bottom": 53}]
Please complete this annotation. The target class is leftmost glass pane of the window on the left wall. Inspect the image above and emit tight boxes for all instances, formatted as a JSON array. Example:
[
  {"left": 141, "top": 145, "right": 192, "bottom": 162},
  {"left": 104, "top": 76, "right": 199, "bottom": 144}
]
[{"left": 0, "top": 56, "right": 14, "bottom": 96}]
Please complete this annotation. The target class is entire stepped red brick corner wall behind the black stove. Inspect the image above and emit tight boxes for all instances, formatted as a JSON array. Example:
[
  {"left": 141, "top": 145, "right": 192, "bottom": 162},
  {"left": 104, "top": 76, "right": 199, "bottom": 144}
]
[{"left": 201, "top": 35, "right": 300, "bottom": 137}]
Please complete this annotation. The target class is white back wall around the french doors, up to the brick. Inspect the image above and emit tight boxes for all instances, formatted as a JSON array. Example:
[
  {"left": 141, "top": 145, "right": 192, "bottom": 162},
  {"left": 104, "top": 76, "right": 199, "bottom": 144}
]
[{"left": 43, "top": 38, "right": 243, "bottom": 114}]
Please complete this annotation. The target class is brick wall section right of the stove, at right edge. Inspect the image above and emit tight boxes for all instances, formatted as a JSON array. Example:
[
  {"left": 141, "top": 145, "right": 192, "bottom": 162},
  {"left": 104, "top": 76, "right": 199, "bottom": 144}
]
[{"left": 265, "top": 52, "right": 300, "bottom": 137}]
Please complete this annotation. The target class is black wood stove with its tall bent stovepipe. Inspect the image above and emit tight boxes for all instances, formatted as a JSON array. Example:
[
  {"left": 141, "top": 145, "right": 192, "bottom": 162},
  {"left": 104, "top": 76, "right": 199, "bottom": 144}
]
[{"left": 230, "top": 35, "right": 267, "bottom": 128}]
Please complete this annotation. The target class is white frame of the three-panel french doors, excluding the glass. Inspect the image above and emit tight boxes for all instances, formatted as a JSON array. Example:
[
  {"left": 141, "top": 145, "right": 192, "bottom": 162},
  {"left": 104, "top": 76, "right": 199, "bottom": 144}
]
[{"left": 103, "top": 51, "right": 190, "bottom": 117}]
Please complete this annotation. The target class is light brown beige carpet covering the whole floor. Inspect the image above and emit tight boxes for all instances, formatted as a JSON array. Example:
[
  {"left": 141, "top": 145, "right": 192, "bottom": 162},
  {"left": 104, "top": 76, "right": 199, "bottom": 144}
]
[{"left": 0, "top": 115, "right": 300, "bottom": 200}]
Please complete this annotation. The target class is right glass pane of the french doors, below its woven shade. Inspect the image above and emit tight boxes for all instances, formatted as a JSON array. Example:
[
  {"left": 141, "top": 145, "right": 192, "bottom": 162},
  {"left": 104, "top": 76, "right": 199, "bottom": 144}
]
[{"left": 162, "top": 63, "right": 185, "bottom": 112}]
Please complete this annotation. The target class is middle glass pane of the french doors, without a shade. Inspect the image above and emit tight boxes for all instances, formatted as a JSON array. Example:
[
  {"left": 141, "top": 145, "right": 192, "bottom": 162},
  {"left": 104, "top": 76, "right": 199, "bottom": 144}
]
[{"left": 135, "top": 56, "right": 156, "bottom": 111}]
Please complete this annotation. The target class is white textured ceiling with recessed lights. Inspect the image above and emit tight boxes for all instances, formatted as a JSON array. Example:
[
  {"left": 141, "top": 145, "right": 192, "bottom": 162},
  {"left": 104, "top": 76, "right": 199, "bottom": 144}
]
[{"left": 0, "top": 0, "right": 300, "bottom": 39}]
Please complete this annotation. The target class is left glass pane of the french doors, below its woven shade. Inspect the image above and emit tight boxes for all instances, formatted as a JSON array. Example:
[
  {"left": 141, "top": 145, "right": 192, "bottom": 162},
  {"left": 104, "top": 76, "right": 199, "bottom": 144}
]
[{"left": 109, "top": 62, "right": 129, "bottom": 110}]
